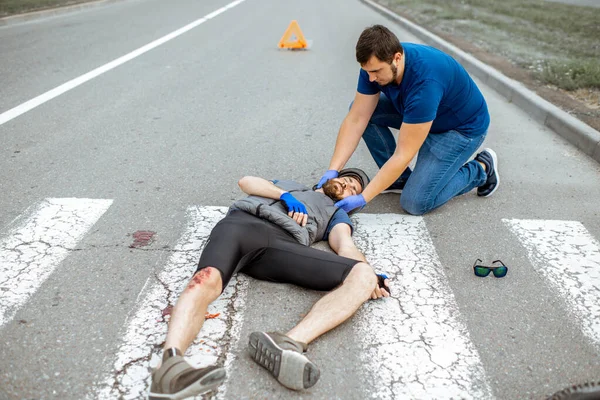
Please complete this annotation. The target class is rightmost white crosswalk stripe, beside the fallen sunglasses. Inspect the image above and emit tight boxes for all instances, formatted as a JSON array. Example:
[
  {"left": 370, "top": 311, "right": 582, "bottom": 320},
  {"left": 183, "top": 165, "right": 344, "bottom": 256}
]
[{"left": 502, "top": 219, "right": 600, "bottom": 346}]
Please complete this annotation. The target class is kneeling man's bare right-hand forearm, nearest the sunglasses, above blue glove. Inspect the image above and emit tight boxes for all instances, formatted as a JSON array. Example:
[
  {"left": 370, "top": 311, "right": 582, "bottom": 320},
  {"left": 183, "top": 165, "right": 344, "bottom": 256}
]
[{"left": 362, "top": 121, "right": 433, "bottom": 203}]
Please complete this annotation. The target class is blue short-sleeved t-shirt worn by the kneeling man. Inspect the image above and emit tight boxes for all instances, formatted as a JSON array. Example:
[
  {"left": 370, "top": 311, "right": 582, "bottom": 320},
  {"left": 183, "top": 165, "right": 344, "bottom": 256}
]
[{"left": 357, "top": 43, "right": 490, "bottom": 137}]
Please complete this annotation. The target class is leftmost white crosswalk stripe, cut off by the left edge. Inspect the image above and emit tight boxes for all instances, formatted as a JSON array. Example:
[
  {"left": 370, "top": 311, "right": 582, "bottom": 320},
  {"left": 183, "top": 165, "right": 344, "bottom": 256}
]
[{"left": 0, "top": 198, "right": 112, "bottom": 327}]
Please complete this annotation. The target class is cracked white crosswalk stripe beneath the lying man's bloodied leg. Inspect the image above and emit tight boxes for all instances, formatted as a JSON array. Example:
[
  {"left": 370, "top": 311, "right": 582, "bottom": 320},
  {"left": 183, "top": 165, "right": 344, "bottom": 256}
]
[{"left": 88, "top": 207, "right": 248, "bottom": 400}]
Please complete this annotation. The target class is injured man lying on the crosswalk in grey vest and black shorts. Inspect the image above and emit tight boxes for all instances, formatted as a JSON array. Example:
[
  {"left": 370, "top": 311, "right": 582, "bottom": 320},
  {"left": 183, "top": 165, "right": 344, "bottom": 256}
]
[{"left": 149, "top": 168, "right": 389, "bottom": 400}]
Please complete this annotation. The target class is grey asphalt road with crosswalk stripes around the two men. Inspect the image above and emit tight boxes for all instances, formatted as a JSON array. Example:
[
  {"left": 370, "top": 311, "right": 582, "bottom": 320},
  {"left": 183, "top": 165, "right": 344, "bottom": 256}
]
[{"left": 0, "top": 0, "right": 600, "bottom": 399}]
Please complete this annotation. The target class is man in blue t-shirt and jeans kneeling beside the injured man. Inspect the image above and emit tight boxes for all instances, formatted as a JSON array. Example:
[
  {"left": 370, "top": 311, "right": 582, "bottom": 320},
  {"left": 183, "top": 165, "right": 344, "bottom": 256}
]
[{"left": 317, "top": 25, "right": 499, "bottom": 215}]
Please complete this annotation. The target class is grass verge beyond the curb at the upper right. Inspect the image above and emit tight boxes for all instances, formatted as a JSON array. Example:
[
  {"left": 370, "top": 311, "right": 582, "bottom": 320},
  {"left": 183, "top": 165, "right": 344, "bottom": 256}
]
[{"left": 378, "top": 0, "right": 600, "bottom": 90}]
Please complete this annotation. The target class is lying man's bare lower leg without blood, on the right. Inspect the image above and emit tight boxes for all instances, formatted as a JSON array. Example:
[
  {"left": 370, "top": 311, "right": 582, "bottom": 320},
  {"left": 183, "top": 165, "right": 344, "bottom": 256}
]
[{"left": 286, "top": 262, "right": 377, "bottom": 344}]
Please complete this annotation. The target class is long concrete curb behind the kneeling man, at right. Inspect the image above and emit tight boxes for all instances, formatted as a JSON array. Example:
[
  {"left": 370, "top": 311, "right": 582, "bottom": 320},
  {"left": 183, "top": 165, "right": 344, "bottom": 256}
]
[{"left": 360, "top": 0, "right": 600, "bottom": 163}]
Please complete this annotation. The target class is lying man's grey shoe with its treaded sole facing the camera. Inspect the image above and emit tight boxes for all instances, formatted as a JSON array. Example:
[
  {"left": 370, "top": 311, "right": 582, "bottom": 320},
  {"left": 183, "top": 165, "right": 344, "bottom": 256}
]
[{"left": 248, "top": 332, "right": 321, "bottom": 390}]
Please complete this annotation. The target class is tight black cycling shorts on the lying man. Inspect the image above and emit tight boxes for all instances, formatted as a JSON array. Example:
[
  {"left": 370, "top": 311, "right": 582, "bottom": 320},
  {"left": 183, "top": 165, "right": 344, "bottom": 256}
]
[{"left": 196, "top": 210, "right": 359, "bottom": 290}]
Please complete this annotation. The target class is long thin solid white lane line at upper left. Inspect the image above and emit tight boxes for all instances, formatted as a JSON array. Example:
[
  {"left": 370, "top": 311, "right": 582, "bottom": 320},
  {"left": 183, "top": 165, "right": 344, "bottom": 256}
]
[{"left": 0, "top": 0, "right": 245, "bottom": 125}]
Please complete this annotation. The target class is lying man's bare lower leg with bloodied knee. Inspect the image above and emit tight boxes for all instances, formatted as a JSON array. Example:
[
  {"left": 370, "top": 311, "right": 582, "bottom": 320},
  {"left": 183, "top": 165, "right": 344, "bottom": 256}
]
[{"left": 164, "top": 267, "right": 223, "bottom": 353}]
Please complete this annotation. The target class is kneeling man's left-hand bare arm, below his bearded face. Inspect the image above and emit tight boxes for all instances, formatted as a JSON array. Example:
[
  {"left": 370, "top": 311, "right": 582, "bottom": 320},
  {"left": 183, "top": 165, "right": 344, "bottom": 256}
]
[{"left": 329, "top": 92, "right": 379, "bottom": 171}]
